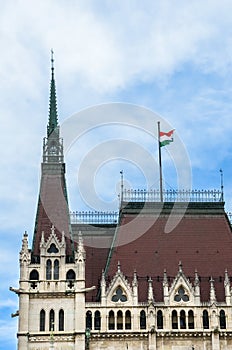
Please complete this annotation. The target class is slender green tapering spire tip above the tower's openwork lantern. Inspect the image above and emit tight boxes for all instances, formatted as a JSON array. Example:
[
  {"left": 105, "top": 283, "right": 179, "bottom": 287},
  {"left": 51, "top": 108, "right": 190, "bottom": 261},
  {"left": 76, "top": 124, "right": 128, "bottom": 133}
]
[{"left": 47, "top": 50, "right": 58, "bottom": 137}]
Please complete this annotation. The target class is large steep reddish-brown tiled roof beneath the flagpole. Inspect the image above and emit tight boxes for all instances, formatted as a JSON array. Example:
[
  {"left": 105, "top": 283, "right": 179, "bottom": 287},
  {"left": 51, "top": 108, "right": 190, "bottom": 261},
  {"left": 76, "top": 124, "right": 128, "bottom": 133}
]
[{"left": 81, "top": 202, "right": 232, "bottom": 301}]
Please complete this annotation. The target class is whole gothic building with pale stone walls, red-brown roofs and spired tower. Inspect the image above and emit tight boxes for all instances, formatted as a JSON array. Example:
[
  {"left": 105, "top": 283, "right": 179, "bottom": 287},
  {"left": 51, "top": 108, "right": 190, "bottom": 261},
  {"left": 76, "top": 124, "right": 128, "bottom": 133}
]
[{"left": 10, "top": 61, "right": 232, "bottom": 350}]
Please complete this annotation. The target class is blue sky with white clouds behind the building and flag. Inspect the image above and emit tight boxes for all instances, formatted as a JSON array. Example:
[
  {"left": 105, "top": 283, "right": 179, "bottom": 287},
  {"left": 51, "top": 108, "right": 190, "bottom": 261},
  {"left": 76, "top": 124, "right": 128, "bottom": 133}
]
[{"left": 0, "top": 0, "right": 232, "bottom": 350}]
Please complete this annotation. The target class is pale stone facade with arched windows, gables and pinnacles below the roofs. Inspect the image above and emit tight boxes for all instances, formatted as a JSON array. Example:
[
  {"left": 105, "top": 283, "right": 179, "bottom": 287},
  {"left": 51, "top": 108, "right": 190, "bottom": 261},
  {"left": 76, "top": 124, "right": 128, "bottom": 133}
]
[{"left": 13, "top": 227, "right": 232, "bottom": 350}]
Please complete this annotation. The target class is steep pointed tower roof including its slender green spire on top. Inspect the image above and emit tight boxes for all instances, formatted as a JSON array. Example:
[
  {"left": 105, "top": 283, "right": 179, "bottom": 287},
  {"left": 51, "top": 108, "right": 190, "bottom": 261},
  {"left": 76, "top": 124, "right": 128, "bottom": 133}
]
[{"left": 32, "top": 52, "right": 73, "bottom": 261}]
